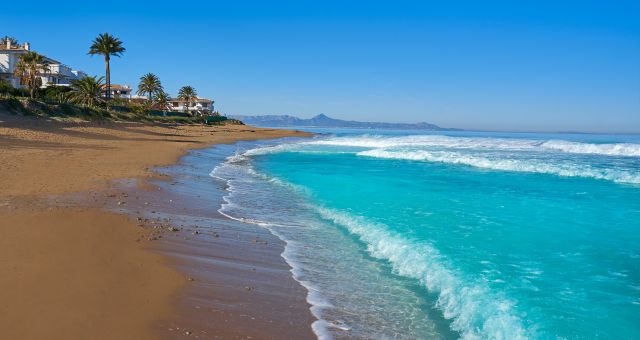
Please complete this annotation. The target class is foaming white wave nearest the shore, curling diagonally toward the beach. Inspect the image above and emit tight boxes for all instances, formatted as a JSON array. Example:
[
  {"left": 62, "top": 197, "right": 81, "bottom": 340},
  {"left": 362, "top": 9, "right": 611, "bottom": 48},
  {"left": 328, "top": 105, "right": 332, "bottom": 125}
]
[{"left": 317, "top": 207, "right": 530, "bottom": 339}]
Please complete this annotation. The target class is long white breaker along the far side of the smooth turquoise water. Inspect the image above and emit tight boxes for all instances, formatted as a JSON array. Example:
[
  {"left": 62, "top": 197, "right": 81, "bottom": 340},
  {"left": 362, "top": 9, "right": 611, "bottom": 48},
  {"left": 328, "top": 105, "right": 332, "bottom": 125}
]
[{"left": 357, "top": 149, "right": 640, "bottom": 184}]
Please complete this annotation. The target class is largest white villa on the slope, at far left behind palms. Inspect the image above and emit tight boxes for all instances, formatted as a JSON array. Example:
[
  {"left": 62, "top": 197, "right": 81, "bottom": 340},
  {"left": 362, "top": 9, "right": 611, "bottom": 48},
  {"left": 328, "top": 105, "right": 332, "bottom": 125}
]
[{"left": 0, "top": 41, "right": 87, "bottom": 88}]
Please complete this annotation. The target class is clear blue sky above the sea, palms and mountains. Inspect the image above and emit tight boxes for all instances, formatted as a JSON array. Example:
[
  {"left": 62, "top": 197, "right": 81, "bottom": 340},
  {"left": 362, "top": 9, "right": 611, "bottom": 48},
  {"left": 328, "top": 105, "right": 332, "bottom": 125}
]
[{"left": 0, "top": 0, "right": 640, "bottom": 133}]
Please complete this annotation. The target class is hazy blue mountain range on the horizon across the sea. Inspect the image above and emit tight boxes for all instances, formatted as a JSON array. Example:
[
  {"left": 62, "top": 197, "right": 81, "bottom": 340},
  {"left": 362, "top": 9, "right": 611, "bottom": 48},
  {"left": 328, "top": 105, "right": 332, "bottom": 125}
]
[{"left": 229, "top": 114, "right": 458, "bottom": 130}]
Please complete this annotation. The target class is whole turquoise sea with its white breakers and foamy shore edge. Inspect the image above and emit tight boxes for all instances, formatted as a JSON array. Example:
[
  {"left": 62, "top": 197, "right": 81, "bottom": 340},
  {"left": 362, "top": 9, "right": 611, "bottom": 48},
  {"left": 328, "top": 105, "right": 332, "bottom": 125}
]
[{"left": 212, "top": 130, "right": 640, "bottom": 339}]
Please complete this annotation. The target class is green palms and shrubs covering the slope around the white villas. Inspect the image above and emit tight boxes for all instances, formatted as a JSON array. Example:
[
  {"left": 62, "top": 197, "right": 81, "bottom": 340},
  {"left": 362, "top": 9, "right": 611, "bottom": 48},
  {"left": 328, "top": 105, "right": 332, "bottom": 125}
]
[{"left": 0, "top": 33, "right": 235, "bottom": 125}]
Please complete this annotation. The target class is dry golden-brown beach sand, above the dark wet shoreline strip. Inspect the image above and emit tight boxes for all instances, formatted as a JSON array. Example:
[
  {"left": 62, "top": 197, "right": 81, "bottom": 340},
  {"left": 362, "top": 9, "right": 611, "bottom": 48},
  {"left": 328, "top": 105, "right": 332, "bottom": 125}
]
[{"left": 0, "top": 114, "right": 314, "bottom": 339}]
